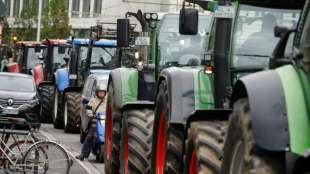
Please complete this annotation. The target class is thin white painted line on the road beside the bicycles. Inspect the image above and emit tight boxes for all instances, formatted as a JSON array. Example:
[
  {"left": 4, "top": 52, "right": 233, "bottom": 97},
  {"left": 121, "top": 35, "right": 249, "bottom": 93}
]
[{"left": 39, "top": 130, "right": 101, "bottom": 174}]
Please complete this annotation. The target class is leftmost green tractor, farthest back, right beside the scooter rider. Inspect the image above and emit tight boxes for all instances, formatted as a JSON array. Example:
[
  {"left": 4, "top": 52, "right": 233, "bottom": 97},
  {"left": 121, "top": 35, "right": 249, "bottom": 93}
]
[{"left": 105, "top": 11, "right": 211, "bottom": 173}]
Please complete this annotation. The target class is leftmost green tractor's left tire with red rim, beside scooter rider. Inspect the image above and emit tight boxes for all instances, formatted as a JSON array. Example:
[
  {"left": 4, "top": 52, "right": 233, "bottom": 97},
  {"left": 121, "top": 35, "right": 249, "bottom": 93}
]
[{"left": 104, "top": 82, "right": 122, "bottom": 174}]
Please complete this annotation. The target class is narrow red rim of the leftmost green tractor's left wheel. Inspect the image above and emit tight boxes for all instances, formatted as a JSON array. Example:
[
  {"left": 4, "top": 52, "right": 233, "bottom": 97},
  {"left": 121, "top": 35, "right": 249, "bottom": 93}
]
[{"left": 105, "top": 104, "right": 112, "bottom": 160}]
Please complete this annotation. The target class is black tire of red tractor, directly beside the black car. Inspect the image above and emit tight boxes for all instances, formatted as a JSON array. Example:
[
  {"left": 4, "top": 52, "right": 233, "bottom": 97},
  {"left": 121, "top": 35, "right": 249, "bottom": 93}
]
[{"left": 39, "top": 84, "right": 54, "bottom": 123}]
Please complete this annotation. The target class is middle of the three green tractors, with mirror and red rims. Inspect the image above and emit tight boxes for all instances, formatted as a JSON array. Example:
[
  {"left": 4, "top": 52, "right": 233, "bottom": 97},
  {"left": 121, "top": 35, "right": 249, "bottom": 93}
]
[{"left": 151, "top": 0, "right": 301, "bottom": 174}]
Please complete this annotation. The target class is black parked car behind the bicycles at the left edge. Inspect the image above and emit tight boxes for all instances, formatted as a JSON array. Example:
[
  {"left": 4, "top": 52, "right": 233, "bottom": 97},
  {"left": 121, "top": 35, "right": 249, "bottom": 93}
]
[{"left": 0, "top": 72, "right": 40, "bottom": 126}]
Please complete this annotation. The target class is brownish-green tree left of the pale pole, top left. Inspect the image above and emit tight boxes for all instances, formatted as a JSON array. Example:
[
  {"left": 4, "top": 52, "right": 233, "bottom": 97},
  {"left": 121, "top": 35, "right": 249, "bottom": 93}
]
[{"left": 13, "top": 0, "right": 38, "bottom": 40}]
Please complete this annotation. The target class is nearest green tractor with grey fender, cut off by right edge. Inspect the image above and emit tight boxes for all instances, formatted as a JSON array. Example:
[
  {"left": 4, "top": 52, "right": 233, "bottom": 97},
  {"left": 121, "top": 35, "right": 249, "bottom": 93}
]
[{"left": 223, "top": 0, "right": 310, "bottom": 174}]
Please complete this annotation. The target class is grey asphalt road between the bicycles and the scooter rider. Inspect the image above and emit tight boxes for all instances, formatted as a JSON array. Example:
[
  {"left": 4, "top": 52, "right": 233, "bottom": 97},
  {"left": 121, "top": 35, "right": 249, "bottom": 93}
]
[{"left": 40, "top": 124, "right": 104, "bottom": 174}]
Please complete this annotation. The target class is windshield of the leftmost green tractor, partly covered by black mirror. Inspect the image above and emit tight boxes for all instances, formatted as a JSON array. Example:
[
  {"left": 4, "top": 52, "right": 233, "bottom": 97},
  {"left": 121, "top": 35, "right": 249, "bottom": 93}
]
[{"left": 158, "top": 14, "right": 211, "bottom": 66}]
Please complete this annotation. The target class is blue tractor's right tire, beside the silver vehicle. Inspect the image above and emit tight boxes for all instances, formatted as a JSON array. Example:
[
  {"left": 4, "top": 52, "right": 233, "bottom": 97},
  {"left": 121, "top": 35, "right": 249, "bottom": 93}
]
[{"left": 63, "top": 92, "right": 82, "bottom": 133}]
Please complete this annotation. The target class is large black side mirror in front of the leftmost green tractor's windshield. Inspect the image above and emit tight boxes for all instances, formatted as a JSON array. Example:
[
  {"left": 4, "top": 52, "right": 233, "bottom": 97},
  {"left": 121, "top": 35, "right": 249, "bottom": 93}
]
[{"left": 179, "top": 7, "right": 199, "bottom": 35}]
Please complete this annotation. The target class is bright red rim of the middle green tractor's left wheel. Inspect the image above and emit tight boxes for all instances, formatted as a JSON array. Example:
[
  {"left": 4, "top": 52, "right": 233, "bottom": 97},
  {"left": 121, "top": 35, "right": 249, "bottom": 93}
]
[{"left": 156, "top": 111, "right": 166, "bottom": 174}]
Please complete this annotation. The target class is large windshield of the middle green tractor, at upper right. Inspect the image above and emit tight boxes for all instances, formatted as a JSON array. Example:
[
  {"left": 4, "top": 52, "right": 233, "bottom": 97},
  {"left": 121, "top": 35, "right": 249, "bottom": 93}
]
[{"left": 233, "top": 5, "right": 300, "bottom": 68}]
